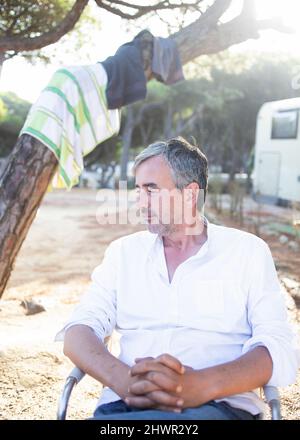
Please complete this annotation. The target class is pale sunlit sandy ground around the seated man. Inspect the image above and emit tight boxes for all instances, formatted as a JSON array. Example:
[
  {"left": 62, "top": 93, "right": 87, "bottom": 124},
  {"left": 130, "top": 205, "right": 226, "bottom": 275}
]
[{"left": 0, "top": 189, "right": 300, "bottom": 420}]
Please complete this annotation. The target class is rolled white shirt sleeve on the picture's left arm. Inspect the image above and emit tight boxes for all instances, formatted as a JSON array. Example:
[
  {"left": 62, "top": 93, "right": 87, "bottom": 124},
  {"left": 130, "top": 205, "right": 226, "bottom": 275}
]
[{"left": 55, "top": 240, "right": 120, "bottom": 342}]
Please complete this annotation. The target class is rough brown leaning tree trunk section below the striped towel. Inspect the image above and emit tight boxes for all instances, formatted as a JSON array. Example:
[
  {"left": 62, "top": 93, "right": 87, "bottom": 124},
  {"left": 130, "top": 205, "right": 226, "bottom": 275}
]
[{"left": 0, "top": 135, "right": 57, "bottom": 297}]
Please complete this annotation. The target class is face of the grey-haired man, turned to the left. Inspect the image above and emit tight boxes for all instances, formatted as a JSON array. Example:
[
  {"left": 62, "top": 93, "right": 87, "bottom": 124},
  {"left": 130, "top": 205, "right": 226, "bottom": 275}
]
[{"left": 136, "top": 156, "right": 183, "bottom": 236}]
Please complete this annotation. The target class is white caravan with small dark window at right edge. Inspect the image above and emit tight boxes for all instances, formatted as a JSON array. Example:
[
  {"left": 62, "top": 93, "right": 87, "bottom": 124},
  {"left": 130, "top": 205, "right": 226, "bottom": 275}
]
[{"left": 253, "top": 98, "right": 300, "bottom": 205}]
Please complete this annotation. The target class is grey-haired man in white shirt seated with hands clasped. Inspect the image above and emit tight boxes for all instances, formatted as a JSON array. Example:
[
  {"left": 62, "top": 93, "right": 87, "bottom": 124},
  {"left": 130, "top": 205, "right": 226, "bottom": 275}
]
[{"left": 60, "top": 138, "right": 297, "bottom": 420}]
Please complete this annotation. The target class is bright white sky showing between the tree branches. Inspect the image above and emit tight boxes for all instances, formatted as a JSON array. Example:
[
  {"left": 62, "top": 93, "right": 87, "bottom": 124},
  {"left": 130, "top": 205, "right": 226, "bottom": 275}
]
[{"left": 0, "top": 0, "right": 300, "bottom": 102}]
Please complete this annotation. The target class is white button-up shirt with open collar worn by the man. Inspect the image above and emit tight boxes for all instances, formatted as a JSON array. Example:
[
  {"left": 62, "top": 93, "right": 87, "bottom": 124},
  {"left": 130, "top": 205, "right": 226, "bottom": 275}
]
[{"left": 57, "top": 222, "right": 298, "bottom": 414}]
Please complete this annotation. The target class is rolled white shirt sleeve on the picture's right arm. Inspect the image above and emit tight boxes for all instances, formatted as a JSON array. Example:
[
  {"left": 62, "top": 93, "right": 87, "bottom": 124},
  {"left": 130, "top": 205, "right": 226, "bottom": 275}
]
[{"left": 243, "top": 240, "right": 299, "bottom": 387}]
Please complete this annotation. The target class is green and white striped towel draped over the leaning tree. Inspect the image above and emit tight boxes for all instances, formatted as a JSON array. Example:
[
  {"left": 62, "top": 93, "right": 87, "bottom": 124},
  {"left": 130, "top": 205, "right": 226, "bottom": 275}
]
[{"left": 21, "top": 63, "right": 120, "bottom": 189}]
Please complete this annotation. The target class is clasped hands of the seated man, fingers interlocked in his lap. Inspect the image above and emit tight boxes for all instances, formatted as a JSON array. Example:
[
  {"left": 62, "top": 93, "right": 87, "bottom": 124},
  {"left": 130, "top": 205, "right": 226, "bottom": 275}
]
[{"left": 124, "top": 354, "right": 198, "bottom": 412}]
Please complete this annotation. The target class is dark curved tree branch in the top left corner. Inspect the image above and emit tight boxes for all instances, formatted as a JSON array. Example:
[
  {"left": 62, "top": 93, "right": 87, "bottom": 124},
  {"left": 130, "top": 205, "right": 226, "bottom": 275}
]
[{"left": 0, "top": 0, "right": 89, "bottom": 52}]
